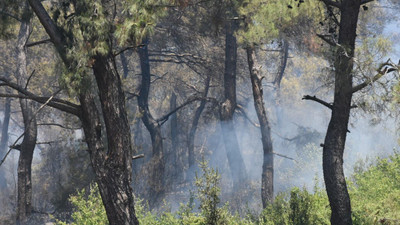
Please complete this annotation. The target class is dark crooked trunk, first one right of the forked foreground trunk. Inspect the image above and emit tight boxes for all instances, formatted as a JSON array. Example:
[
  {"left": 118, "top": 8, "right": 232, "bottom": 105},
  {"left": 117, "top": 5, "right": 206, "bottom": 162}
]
[{"left": 138, "top": 39, "right": 165, "bottom": 205}]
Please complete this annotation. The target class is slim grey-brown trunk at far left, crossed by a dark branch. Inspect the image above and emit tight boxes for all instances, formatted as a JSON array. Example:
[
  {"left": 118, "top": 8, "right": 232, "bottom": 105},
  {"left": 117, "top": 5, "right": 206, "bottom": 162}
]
[{"left": 16, "top": 7, "right": 37, "bottom": 224}]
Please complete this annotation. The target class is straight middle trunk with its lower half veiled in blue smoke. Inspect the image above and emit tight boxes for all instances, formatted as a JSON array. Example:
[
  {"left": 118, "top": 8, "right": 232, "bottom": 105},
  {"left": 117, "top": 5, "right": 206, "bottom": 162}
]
[{"left": 220, "top": 13, "right": 246, "bottom": 188}]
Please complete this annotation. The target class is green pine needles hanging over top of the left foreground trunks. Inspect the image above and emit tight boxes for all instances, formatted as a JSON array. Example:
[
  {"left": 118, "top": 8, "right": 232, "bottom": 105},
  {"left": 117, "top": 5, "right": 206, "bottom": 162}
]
[{"left": 51, "top": 0, "right": 168, "bottom": 94}]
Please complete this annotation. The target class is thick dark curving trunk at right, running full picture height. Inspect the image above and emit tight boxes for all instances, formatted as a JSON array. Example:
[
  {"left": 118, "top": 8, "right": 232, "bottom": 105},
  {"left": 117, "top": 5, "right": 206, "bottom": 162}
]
[{"left": 323, "top": 0, "right": 360, "bottom": 225}]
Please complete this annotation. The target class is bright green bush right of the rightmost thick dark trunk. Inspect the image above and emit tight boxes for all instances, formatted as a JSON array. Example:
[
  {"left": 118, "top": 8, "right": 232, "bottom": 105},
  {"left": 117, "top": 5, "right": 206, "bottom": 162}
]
[{"left": 349, "top": 151, "right": 400, "bottom": 224}]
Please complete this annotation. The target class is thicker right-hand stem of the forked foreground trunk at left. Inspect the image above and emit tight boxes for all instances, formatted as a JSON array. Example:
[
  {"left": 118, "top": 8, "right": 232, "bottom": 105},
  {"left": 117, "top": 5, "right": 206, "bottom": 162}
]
[{"left": 93, "top": 55, "right": 138, "bottom": 224}]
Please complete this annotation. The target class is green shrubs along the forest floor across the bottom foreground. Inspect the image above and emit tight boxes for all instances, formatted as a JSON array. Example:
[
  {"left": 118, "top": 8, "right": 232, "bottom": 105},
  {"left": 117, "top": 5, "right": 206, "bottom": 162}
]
[{"left": 59, "top": 152, "right": 400, "bottom": 225}]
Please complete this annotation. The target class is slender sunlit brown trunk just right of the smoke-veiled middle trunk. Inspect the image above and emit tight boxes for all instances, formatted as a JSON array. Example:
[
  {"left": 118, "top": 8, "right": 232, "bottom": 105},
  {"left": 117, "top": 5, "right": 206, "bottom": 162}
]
[{"left": 246, "top": 46, "right": 274, "bottom": 208}]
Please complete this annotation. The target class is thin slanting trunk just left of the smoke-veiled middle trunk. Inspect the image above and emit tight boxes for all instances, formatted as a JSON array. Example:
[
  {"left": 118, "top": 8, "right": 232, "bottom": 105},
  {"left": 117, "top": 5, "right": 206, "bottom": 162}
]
[{"left": 188, "top": 76, "right": 210, "bottom": 169}]
